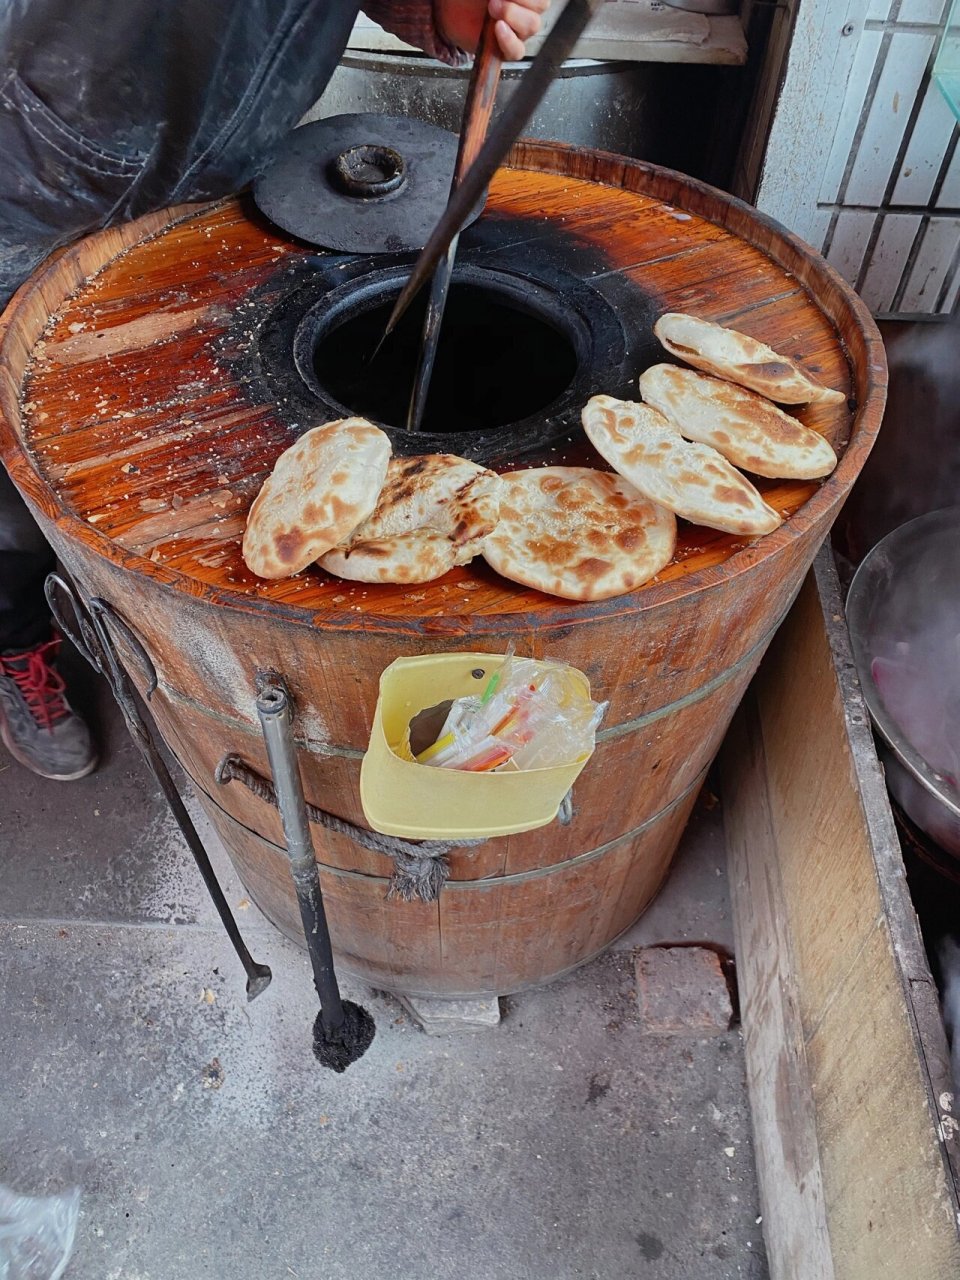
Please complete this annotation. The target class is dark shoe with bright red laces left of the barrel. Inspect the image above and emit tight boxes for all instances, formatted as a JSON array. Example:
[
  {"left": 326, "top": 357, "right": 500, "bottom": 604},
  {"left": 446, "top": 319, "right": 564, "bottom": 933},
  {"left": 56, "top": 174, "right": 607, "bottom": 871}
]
[{"left": 0, "top": 637, "right": 97, "bottom": 782}]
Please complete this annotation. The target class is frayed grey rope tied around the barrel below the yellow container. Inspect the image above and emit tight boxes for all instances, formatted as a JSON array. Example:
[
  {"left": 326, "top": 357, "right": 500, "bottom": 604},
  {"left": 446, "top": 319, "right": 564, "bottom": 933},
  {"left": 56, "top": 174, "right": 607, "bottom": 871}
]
[{"left": 214, "top": 753, "right": 485, "bottom": 902}]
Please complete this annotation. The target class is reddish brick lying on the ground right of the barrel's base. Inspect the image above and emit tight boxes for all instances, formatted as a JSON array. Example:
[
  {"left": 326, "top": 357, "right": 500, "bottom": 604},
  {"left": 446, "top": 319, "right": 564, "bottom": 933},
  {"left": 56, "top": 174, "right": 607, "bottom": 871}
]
[{"left": 636, "top": 947, "right": 733, "bottom": 1036}]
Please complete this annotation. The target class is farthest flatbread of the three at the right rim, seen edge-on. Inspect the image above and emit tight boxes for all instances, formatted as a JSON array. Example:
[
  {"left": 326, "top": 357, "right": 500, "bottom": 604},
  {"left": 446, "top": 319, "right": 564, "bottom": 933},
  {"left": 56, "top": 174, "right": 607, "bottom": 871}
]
[{"left": 653, "top": 311, "right": 846, "bottom": 404}]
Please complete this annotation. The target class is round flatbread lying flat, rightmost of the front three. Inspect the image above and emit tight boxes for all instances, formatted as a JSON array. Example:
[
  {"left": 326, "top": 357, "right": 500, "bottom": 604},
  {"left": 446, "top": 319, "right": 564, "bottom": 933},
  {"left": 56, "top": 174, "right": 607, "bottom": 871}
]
[{"left": 484, "top": 467, "right": 677, "bottom": 600}]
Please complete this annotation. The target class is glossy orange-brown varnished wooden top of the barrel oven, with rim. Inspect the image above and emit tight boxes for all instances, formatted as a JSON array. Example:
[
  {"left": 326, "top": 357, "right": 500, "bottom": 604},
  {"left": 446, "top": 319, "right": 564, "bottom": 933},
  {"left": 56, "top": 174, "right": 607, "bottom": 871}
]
[{"left": 0, "top": 143, "right": 883, "bottom": 630}]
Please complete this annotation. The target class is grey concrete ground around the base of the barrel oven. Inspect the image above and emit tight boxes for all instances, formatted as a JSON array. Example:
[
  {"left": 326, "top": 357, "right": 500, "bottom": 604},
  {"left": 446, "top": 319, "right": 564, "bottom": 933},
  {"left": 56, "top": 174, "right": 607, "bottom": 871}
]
[{"left": 0, "top": 650, "right": 767, "bottom": 1280}]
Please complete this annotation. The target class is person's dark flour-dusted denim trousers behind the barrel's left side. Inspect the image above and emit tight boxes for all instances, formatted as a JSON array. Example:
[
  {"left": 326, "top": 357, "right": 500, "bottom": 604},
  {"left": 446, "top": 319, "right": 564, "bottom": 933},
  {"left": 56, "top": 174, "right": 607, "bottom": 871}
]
[{"left": 0, "top": 0, "right": 358, "bottom": 653}]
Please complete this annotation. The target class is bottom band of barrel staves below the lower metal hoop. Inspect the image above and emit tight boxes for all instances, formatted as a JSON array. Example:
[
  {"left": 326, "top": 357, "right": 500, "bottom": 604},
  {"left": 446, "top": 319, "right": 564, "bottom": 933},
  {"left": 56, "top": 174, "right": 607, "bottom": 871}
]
[{"left": 200, "top": 786, "right": 698, "bottom": 1000}]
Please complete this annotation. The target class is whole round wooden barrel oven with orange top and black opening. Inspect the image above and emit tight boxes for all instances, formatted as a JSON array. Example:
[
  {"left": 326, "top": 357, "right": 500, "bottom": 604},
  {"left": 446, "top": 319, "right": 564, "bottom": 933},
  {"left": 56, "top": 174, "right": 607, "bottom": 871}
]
[{"left": 1, "top": 143, "right": 886, "bottom": 997}]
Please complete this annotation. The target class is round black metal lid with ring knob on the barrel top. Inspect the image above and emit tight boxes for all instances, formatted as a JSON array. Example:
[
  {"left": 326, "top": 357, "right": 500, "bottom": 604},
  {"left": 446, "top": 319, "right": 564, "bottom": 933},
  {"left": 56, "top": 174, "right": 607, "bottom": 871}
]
[{"left": 253, "top": 114, "right": 484, "bottom": 253}]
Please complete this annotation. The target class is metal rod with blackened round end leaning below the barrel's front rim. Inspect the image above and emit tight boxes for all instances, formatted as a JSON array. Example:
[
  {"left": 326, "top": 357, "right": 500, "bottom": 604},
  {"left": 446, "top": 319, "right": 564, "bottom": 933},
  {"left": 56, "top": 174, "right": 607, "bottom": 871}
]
[{"left": 257, "top": 677, "right": 375, "bottom": 1071}]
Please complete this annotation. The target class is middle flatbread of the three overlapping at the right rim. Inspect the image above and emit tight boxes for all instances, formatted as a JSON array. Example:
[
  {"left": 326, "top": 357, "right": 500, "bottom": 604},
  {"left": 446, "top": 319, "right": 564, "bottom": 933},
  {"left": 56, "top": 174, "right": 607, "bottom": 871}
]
[{"left": 640, "top": 365, "right": 837, "bottom": 480}]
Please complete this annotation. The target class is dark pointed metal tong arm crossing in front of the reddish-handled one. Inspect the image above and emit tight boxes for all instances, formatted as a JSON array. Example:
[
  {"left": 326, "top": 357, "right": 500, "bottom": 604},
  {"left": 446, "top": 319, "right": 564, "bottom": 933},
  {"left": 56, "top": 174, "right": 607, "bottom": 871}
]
[{"left": 370, "top": 0, "right": 603, "bottom": 360}]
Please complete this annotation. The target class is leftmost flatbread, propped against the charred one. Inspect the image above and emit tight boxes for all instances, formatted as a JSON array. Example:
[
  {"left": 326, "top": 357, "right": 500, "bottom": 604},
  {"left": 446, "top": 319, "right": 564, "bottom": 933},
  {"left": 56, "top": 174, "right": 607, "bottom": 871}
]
[{"left": 243, "top": 417, "right": 392, "bottom": 579}]
